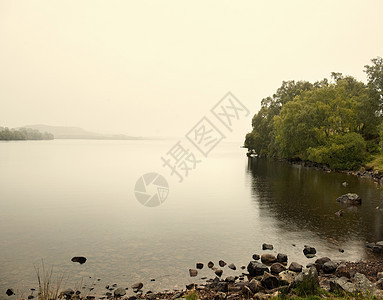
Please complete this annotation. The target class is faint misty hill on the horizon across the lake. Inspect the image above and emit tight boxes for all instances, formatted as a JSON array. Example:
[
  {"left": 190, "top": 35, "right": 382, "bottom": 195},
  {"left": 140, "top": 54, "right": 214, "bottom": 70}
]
[{"left": 23, "top": 124, "right": 143, "bottom": 140}]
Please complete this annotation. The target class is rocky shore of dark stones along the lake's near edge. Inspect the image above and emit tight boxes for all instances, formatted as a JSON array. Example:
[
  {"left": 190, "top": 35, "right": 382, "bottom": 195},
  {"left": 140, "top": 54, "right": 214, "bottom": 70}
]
[{"left": 6, "top": 245, "right": 383, "bottom": 300}]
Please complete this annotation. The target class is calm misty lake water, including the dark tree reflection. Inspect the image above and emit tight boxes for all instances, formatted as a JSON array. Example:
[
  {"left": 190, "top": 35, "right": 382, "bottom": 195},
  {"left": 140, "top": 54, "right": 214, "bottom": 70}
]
[{"left": 0, "top": 140, "right": 383, "bottom": 299}]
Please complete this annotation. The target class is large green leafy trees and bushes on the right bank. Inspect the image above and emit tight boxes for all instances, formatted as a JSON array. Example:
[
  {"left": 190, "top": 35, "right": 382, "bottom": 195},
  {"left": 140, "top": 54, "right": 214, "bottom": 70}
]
[{"left": 245, "top": 58, "right": 383, "bottom": 169}]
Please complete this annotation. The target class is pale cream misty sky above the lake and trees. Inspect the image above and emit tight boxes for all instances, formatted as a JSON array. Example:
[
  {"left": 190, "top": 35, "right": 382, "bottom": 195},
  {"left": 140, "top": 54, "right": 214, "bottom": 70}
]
[{"left": 0, "top": 0, "right": 383, "bottom": 139}]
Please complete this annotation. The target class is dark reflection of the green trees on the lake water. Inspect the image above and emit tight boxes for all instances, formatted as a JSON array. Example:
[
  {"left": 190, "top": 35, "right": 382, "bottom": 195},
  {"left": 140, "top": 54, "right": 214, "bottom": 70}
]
[{"left": 248, "top": 158, "right": 383, "bottom": 248}]
